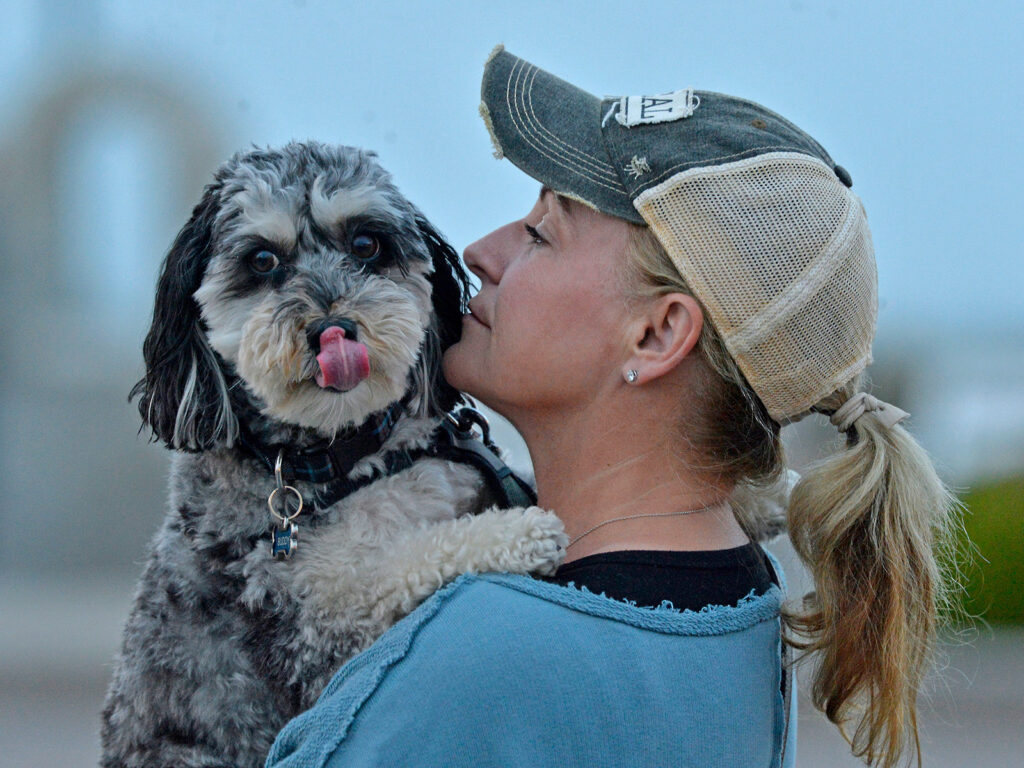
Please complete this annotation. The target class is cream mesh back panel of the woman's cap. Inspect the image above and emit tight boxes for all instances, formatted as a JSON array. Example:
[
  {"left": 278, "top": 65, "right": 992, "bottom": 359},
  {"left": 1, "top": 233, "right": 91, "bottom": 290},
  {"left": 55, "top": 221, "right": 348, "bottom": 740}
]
[{"left": 635, "top": 153, "right": 878, "bottom": 421}]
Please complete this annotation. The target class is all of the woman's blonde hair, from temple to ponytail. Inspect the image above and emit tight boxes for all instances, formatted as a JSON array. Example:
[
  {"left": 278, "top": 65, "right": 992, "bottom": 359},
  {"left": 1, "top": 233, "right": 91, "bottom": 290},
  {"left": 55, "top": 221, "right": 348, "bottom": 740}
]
[{"left": 628, "top": 224, "right": 956, "bottom": 768}]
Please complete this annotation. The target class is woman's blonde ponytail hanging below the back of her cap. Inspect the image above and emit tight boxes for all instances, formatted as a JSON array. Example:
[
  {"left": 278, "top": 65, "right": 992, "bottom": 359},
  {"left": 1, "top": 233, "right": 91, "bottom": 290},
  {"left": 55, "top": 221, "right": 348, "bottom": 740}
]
[{"left": 783, "top": 383, "right": 957, "bottom": 768}]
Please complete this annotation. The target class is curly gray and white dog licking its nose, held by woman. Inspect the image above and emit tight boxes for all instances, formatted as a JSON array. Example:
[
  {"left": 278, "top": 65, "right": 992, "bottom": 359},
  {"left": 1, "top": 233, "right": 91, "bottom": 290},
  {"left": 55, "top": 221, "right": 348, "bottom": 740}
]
[{"left": 101, "top": 143, "right": 566, "bottom": 768}]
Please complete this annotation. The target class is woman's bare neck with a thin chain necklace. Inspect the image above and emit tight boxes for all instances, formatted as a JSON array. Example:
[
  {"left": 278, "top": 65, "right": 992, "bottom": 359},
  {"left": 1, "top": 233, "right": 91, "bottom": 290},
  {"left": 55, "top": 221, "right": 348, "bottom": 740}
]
[{"left": 522, "top": 399, "right": 748, "bottom": 561}]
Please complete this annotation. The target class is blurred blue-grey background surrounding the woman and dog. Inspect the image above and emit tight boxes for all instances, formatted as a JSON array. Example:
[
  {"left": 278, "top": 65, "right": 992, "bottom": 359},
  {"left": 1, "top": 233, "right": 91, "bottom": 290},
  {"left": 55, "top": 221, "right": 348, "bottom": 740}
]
[{"left": 0, "top": 0, "right": 1024, "bottom": 767}]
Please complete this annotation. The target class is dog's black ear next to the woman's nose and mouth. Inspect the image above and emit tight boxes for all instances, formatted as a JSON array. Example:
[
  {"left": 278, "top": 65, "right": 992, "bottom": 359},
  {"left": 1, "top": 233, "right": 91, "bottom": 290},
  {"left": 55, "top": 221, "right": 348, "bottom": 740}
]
[{"left": 416, "top": 214, "right": 470, "bottom": 416}]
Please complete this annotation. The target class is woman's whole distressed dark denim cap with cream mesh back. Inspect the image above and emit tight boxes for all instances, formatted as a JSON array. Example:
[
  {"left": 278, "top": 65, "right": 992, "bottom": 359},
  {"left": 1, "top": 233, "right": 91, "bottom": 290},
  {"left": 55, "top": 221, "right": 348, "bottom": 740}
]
[{"left": 480, "top": 46, "right": 878, "bottom": 423}]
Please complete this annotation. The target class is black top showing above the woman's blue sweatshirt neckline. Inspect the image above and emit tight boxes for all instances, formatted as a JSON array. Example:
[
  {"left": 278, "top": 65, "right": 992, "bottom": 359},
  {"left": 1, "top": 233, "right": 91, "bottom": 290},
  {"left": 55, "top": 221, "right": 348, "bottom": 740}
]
[{"left": 545, "top": 542, "right": 775, "bottom": 610}]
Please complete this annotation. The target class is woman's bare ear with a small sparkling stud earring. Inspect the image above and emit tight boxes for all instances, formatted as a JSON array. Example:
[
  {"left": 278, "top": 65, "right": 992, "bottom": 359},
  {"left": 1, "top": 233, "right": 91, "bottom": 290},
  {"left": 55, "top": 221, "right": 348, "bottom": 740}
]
[{"left": 623, "top": 293, "right": 703, "bottom": 384}]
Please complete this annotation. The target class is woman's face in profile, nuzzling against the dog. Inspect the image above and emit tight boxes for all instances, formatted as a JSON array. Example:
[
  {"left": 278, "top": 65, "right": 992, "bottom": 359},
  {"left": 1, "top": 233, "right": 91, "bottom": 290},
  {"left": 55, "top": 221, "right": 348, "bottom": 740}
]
[{"left": 444, "top": 188, "right": 636, "bottom": 423}]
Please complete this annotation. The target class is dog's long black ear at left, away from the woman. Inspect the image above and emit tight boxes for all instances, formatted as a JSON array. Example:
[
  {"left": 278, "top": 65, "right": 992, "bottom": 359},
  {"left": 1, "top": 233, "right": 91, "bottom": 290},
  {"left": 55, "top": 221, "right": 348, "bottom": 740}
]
[{"left": 129, "top": 183, "right": 238, "bottom": 452}]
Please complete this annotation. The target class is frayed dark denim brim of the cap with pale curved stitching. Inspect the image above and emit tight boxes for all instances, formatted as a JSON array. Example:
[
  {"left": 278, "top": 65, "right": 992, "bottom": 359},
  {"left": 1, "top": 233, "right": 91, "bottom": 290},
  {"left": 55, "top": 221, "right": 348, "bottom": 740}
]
[{"left": 480, "top": 46, "right": 644, "bottom": 224}]
